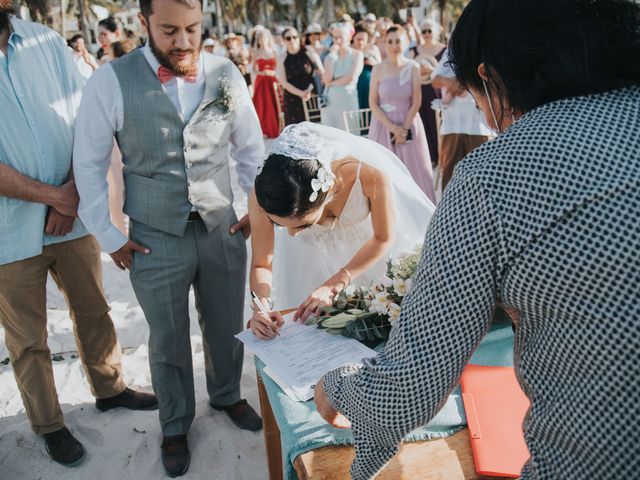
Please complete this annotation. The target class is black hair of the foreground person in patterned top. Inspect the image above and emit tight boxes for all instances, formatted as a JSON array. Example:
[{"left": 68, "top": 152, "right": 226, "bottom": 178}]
[{"left": 449, "top": 0, "right": 640, "bottom": 122}]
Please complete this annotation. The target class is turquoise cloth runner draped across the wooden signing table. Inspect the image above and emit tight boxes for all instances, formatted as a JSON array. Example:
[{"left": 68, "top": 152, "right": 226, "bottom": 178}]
[{"left": 255, "top": 324, "right": 513, "bottom": 480}]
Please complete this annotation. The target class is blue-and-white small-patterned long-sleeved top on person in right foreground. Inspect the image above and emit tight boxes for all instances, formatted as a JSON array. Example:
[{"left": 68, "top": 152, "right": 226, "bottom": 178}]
[{"left": 324, "top": 87, "right": 640, "bottom": 480}]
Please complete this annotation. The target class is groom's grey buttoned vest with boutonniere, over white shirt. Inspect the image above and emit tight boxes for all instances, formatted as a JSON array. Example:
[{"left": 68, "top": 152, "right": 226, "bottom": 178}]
[{"left": 111, "top": 49, "right": 235, "bottom": 235}]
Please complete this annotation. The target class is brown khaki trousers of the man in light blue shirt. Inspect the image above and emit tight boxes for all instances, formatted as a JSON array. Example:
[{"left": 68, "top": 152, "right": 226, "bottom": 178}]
[{"left": 0, "top": 236, "right": 125, "bottom": 435}]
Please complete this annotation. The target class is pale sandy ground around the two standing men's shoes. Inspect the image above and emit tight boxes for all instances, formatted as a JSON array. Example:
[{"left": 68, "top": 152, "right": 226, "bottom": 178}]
[{"left": 0, "top": 160, "right": 268, "bottom": 480}]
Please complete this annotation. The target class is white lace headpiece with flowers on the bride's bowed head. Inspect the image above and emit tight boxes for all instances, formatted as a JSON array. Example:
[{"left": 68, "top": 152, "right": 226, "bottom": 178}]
[{"left": 258, "top": 122, "right": 336, "bottom": 202}]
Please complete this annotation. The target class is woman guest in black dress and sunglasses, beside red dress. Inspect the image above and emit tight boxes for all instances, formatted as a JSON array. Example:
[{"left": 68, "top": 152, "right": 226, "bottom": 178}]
[{"left": 276, "top": 27, "right": 324, "bottom": 125}]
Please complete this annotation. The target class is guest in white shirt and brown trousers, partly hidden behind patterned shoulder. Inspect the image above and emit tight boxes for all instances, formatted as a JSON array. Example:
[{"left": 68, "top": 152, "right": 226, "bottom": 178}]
[{"left": 431, "top": 50, "right": 491, "bottom": 192}]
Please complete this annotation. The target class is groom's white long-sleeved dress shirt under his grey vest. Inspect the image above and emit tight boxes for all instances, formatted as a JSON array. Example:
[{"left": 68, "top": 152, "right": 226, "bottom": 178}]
[{"left": 73, "top": 44, "right": 264, "bottom": 253}]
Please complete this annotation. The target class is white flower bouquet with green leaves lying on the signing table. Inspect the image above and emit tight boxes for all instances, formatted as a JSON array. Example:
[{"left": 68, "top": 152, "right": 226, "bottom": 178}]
[{"left": 306, "top": 245, "right": 422, "bottom": 345}]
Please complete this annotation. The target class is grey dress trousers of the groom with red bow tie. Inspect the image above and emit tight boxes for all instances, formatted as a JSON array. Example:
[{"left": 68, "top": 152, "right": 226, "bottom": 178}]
[{"left": 130, "top": 209, "right": 247, "bottom": 435}]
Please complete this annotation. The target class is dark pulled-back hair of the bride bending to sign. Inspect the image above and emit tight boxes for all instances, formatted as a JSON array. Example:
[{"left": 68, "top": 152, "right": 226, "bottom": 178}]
[{"left": 255, "top": 154, "right": 329, "bottom": 218}]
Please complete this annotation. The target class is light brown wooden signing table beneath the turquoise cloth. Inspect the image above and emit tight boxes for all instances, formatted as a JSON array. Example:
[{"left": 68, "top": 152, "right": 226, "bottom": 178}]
[{"left": 258, "top": 375, "right": 496, "bottom": 480}]
